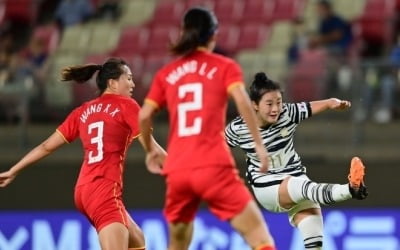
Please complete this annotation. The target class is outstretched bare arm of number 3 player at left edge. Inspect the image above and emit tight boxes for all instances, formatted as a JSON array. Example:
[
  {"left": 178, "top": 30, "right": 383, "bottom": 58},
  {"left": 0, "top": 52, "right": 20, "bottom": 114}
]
[{"left": 0, "top": 132, "right": 66, "bottom": 187}]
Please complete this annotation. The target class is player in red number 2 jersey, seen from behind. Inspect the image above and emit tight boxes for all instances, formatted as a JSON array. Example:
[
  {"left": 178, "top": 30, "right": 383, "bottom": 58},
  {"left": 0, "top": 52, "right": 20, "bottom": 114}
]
[{"left": 139, "top": 8, "right": 275, "bottom": 250}]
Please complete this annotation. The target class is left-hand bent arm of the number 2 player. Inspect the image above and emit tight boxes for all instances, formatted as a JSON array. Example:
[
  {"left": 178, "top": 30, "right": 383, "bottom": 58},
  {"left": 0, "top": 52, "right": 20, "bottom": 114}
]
[{"left": 139, "top": 101, "right": 167, "bottom": 174}]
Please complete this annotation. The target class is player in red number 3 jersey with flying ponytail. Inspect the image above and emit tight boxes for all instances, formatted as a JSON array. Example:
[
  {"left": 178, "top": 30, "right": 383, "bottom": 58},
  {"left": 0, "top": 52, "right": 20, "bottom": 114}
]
[{"left": 0, "top": 58, "right": 165, "bottom": 250}]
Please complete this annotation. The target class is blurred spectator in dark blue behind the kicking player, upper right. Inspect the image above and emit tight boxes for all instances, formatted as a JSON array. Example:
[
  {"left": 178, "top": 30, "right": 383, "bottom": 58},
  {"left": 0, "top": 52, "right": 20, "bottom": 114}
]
[{"left": 312, "top": 0, "right": 353, "bottom": 55}]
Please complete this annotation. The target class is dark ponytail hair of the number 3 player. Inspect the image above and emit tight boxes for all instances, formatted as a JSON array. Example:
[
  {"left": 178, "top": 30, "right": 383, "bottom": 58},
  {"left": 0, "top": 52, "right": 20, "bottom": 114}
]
[{"left": 61, "top": 58, "right": 127, "bottom": 94}]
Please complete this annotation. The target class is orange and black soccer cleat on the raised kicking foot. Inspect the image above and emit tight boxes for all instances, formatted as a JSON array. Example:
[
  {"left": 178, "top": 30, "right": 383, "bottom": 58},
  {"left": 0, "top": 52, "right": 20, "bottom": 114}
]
[{"left": 348, "top": 157, "right": 368, "bottom": 200}]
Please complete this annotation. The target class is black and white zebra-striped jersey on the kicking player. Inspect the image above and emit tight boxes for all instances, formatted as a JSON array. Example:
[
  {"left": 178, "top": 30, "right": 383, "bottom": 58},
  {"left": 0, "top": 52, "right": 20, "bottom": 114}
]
[{"left": 225, "top": 102, "right": 312, "bottom": 185}]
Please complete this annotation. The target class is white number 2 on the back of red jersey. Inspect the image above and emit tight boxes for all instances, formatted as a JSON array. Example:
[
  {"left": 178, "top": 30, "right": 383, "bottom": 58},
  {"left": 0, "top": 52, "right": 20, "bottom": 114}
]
[{"left": 178, "top": 83, "right": 203, "bottom": 137}]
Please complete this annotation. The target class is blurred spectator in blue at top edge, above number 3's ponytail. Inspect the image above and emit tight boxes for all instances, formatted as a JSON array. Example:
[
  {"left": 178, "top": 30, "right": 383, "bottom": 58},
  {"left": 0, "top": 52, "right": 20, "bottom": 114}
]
[{"left": 55, "top": 0, "right": 94, "bottom": 29}]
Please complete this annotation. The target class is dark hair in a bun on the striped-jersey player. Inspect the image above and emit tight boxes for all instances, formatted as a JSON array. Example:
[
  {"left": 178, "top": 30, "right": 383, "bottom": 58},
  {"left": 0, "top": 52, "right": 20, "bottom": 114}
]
[{"left": 249, "top": 72, "right": 282, "bottom": 104}]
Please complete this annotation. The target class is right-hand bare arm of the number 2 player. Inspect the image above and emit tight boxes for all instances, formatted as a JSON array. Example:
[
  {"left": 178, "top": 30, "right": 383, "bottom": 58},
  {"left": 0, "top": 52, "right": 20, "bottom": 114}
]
[{"left": 229, "top": 84, "right": 268, "bottom": 172}]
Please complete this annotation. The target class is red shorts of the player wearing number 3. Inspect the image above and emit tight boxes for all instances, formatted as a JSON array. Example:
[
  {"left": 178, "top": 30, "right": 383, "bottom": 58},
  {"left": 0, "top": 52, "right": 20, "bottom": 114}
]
[{"left": 75, "top": 177, "right": 129, "bottom": 232}]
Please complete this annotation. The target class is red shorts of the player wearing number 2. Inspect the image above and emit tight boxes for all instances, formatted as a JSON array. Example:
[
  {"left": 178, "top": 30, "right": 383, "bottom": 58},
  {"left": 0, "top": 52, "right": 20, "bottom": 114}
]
[{"left": 164, "top": 166, "right": 253, "bottom": 223}]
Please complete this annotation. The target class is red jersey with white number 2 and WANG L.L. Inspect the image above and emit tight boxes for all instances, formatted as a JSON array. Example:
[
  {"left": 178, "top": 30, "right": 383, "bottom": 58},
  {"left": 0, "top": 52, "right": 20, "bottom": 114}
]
[{"left": 145, "top": 50, "right": 243, "bottom": 173}]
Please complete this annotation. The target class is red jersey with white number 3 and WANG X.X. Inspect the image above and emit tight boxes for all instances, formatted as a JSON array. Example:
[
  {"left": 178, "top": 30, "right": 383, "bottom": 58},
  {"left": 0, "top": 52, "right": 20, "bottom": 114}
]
[{"left": 57, "top": 94, "right": 140, "bottom": 186}]
